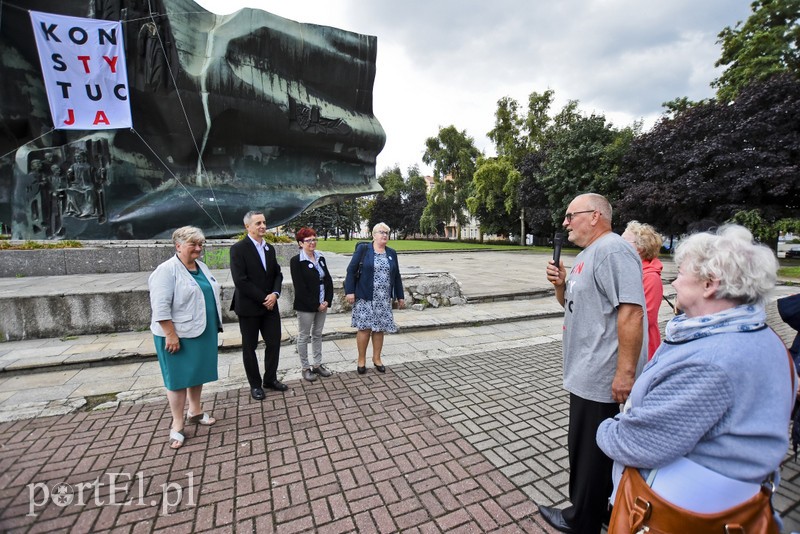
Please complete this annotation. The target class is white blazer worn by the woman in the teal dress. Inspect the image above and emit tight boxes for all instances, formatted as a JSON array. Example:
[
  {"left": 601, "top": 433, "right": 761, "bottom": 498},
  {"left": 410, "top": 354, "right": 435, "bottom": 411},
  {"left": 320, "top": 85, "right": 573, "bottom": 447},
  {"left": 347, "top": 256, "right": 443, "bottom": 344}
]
[{"left": 147, "top": 255, "right": 222, "bottom": 338}]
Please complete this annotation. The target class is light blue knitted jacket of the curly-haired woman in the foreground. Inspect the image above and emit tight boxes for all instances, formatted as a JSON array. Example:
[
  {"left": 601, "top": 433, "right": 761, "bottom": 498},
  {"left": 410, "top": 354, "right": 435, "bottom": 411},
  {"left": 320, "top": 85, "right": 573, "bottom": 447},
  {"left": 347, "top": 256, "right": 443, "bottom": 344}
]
[{"left": 597, "top": 328, "right": 794, "bottom": 483}]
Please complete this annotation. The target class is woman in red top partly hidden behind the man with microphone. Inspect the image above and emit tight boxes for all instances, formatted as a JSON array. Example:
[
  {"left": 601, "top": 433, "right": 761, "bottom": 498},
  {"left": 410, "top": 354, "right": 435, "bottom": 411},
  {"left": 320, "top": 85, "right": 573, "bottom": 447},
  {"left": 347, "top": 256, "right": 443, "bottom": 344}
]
[{"left": 622, "top": 221, "right": 664, "bottom": 360}]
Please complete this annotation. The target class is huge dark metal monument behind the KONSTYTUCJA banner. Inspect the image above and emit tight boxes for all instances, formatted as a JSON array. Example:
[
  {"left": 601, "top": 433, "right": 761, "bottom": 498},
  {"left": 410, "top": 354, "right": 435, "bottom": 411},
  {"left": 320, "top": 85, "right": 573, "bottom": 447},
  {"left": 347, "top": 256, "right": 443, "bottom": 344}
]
[{"left": 0, "top": 0, "right": 386, "bottom": 239}]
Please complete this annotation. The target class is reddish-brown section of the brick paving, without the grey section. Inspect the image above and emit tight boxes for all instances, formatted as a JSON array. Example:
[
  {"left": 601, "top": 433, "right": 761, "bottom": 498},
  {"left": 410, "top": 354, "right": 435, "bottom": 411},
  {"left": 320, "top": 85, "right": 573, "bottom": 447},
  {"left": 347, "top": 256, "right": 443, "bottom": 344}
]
[{"left": 0, "top": 366, "right": 547, "bottom": 533}]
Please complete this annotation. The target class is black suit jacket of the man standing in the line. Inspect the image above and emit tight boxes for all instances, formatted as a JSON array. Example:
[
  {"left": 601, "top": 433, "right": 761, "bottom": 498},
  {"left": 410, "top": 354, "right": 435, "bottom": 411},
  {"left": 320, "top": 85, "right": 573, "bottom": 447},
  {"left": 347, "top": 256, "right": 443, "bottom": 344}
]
[{"left": 230, "top": 236, "right": 283, "bottom": 316}]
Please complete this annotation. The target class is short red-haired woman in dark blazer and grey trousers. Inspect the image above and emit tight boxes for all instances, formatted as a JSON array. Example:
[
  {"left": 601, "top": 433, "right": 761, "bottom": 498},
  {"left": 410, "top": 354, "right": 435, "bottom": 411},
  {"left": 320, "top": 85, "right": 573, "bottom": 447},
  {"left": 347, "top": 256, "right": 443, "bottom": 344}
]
[{"left": 289, "top": 228, "right": 333, "bottom": 382}]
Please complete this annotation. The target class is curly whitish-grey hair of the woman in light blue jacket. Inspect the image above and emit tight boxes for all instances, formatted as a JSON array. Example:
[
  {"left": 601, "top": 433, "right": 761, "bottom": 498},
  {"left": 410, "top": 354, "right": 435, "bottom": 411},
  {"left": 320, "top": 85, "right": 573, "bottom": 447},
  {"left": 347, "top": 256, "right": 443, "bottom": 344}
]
[{"left": 675, "top": 224, "right": 778, "bottom": 305}]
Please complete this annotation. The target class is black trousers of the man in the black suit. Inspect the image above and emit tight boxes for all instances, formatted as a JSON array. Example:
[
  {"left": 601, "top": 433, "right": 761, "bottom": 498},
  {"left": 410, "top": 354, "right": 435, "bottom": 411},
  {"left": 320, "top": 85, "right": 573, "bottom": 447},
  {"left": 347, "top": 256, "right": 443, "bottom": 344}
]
[{"left": 239, "top": 306, "right": 281, "bottom": 388}]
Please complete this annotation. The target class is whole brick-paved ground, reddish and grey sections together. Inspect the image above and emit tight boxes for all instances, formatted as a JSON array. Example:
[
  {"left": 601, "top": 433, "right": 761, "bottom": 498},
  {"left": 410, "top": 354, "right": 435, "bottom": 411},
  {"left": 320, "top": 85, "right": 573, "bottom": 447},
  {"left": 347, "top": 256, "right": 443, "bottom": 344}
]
[{"left": 0, "top": 336, "right": 800, "bottom": 533}]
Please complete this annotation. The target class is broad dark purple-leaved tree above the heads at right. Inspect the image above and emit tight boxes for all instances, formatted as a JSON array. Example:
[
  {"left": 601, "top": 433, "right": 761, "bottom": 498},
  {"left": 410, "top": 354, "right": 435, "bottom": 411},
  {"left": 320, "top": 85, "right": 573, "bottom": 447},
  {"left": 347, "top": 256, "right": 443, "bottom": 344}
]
[{"left": 619, "top": 73, "right": 800, "bottom": 234}]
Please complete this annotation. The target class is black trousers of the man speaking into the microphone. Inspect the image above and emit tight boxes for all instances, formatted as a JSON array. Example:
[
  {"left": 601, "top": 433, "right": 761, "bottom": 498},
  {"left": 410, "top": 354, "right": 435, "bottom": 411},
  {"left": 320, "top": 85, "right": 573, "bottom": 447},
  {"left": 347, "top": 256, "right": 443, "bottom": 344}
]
[{"left": 563, "top": 393, "right": 619, "bottom": 534}]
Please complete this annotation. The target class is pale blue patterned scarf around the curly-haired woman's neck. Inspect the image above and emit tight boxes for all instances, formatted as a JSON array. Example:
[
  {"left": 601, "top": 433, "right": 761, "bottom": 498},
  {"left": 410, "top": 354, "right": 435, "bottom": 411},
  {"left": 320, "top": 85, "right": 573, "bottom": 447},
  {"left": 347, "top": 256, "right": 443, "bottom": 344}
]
[{"left": 665, "top": 304, "right": 767, "bottom": 343}]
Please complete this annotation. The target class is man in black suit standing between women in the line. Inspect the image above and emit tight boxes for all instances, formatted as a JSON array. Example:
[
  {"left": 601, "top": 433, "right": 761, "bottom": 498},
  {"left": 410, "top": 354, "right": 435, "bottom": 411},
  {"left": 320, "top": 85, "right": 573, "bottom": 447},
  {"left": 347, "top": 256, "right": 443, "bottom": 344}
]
[{"left": 231, "top": 211, "right": 289, "bottom": 400}]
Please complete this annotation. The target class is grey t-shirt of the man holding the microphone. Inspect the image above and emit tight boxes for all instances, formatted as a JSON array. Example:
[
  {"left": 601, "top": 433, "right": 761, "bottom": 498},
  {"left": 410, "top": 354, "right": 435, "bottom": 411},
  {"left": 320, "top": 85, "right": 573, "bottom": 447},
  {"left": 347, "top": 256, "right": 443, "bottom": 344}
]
[{"left": 564, "top": 233, "right": 647, "bottom": 402}]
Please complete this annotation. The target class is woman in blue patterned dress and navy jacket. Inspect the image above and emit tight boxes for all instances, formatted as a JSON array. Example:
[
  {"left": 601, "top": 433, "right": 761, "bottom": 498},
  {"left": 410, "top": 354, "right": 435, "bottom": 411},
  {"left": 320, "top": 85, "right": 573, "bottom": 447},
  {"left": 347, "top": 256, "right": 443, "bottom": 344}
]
[{"left": 344, "top": 223, "right": 405, "bottom": 375}]
